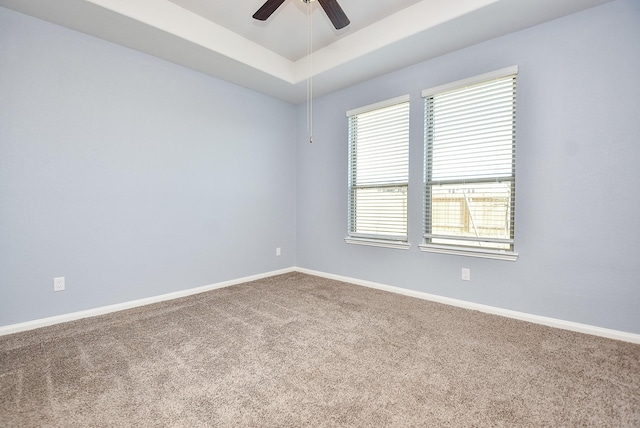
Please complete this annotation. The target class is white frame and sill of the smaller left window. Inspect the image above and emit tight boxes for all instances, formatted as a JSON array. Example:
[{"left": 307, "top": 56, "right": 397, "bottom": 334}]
[{"left": 344, "top": 94, "right": 411, "bottom": 249}]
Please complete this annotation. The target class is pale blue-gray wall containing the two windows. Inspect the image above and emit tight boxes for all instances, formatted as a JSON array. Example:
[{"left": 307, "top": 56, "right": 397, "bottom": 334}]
[{"left": 296, "top": 0, "right": 640, "bottom": 333}]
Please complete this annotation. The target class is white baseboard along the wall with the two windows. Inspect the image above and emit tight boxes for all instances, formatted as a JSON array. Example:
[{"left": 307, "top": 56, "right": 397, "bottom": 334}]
[{"left": 295, "top": 268, "right": 640, "bottom": 344}]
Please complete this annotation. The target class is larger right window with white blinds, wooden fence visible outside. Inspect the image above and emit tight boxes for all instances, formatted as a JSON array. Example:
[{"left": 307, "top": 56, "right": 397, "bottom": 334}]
[{"left": 420, "top": 67, "right": 518, "bottom": 260}]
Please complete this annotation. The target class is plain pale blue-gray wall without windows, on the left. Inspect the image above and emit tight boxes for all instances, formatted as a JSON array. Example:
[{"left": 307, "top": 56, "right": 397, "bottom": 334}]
[{"left": 0, "top": 8, "right": 295, "bottom": 325}]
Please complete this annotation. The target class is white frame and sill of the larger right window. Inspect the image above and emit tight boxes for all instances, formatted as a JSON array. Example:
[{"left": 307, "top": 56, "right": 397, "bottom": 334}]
[{"left": 418, "top": 66, "right": 518, "bottom": 261}]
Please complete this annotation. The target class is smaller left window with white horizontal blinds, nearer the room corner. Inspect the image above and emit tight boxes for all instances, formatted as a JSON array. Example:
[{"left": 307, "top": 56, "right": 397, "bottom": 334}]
[{"left": 345, "top": 96, "right": 409, "bottom": 248}]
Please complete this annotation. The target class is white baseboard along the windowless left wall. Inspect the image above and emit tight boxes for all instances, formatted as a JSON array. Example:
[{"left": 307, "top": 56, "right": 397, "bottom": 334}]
[{"left": 0, "top": 268, "right": 295, "bottom": 336}]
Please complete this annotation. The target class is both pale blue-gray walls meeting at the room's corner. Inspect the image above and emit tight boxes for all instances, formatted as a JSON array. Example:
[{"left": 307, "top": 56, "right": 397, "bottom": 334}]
[{"left": 0, "top": 0, "right": 640, "bottom": 333}]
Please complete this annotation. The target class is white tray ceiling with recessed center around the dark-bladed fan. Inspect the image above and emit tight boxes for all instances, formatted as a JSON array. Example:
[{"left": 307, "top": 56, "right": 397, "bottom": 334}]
[{"left": 0, "top": 0, "right": 612, "bottom": 103}]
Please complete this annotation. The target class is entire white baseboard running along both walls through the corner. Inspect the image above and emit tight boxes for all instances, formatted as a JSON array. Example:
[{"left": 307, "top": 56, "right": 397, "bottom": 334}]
[{"left": 0, "top": 267, "right": 640, "bottom": 344}]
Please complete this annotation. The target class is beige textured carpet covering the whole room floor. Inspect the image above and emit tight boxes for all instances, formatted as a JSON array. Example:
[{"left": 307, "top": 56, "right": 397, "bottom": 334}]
[{"left": 0, "top": 273, "right": 640, "bottom": 427}]
